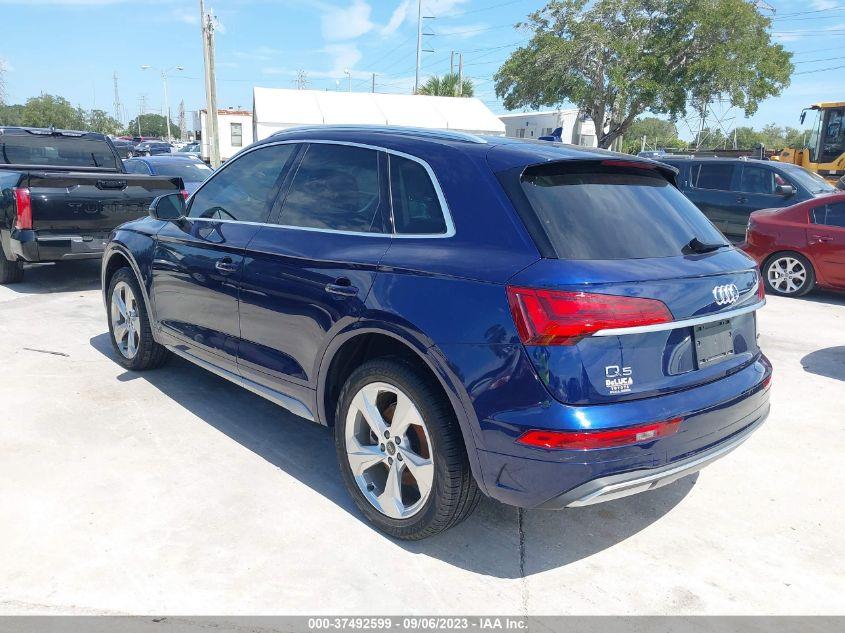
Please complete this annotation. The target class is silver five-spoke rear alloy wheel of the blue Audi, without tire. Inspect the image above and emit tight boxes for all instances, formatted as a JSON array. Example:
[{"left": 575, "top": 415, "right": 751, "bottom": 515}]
[{"left": 345, "top": 382, "right": 434, "bottom": 519}]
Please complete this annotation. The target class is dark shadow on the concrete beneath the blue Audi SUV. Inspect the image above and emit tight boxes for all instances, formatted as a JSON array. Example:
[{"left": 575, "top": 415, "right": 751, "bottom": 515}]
[{"left": 90, "top": 333, "right": 696, "bottom": 578}]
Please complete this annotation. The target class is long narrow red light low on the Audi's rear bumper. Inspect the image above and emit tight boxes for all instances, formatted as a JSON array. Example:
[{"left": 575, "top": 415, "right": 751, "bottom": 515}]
[{"left": 516, "top": 418, "right": 684, "bottom": 451}]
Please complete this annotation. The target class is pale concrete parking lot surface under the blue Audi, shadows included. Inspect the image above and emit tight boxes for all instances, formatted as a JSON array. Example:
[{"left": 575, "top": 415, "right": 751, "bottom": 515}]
[{"left": 0, "top": 262, "right": 845, "bottom": 615}]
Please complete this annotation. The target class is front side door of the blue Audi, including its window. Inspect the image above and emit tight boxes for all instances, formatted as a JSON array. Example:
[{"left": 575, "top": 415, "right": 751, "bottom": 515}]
[{"left": 151, "top": 145, "right": 294, "bottom": 372}]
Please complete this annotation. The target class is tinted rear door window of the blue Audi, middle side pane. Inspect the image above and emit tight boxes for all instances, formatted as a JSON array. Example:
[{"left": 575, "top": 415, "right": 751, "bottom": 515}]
[{"left": 279, "top": 143, "right": 385, "bottom": 233}]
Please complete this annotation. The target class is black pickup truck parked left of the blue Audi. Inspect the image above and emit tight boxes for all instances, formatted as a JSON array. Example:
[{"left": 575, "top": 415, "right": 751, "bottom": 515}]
[{"left": 0, "top": 127, "right": 182, "bottom": 283}]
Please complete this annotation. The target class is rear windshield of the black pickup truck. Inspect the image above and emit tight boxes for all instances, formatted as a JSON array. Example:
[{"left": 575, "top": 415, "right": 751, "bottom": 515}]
[{"left": 0, "top": 134, "right": 117, "bottom": 170}]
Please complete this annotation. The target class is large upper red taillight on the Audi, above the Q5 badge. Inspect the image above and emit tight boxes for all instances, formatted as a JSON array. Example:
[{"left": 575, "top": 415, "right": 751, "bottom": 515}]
[{"left": 508, "top": 286, "right": 672, "bottom": 345}]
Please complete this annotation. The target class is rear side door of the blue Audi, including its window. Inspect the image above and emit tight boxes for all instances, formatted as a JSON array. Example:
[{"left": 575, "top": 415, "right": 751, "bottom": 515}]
[{"left": 238, "top": 142, "right": 391, "bottom": 400}]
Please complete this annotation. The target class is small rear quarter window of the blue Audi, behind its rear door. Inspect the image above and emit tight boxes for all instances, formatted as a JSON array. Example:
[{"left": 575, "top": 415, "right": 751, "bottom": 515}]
[{"left": 390, "top": 154, "right": 446, "bottom": 235}]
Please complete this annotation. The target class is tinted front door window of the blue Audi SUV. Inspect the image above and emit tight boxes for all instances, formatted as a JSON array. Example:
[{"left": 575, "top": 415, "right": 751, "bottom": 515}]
[{"left": 188, "top": 145, "right": 296, "bottom": 222}]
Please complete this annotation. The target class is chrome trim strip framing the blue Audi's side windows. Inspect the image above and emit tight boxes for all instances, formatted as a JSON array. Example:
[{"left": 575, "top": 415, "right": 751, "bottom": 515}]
[{"left": 186, "top": 139, "right": 455, "bottom": 239}]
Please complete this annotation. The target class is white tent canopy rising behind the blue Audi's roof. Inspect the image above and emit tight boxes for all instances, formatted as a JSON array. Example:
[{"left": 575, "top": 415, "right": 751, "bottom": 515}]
[{"left": 252, "top": 88, "right": 505, "bottom": 140}]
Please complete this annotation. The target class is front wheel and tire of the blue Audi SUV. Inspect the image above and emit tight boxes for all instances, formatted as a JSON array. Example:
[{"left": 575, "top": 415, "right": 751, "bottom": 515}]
[{"left": 106, "top": 268, "right": 170, "bottom": 371}]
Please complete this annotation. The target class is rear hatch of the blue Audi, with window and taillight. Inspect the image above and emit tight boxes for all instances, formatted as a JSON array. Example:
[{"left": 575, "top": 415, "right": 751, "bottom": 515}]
[{"left": 500, "top": 159, "right": 762, "bottom": 405}]
